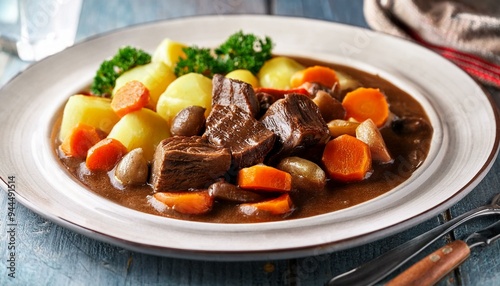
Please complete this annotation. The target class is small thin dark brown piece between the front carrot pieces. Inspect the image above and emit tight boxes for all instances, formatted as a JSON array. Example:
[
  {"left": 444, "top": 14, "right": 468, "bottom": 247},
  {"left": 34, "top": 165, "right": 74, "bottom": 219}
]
[{"left": 208, "top": 180, "right": 265, "bottom": 203}]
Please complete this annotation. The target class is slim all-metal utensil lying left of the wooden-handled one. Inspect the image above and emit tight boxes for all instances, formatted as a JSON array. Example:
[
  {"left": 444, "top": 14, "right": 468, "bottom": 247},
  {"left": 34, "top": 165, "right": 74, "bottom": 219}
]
[{"left": 326, "top": 193, "right": 500, "bottom": 286}]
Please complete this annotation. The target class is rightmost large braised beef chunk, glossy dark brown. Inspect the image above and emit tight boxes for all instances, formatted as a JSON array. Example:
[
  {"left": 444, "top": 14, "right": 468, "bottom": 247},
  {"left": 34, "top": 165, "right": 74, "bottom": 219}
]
[{"left": 261, "top": 94, "right": 330, "bottom": 163}]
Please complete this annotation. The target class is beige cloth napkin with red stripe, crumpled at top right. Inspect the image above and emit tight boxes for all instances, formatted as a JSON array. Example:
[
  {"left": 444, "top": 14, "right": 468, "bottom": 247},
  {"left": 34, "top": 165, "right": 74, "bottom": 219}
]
[{"left": 364, "top": 0, "right": 500, "bottom": 87}]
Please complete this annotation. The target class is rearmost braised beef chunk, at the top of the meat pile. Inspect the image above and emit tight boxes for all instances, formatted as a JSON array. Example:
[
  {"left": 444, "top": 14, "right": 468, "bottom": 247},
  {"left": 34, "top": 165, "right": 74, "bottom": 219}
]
[{"left": 212, "top": 74, "right": 260, "bottom": 117}]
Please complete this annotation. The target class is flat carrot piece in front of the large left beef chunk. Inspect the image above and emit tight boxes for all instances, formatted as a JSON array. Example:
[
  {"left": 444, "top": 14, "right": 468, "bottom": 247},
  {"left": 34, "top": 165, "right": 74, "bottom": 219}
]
[{"left": 153, "top": 190, "right": 214, "bottom": 214}]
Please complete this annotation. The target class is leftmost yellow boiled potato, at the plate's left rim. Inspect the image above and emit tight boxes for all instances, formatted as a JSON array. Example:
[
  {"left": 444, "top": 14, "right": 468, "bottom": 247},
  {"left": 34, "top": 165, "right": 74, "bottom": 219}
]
[{"left": 59, "top": 95, "right": 120, "bottom": 141}]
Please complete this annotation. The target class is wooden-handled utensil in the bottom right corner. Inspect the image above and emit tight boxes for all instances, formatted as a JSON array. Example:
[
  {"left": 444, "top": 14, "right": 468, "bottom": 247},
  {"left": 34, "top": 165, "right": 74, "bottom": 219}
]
[{"left": 386, "top": 221, "right": 500, "bottom": 286}]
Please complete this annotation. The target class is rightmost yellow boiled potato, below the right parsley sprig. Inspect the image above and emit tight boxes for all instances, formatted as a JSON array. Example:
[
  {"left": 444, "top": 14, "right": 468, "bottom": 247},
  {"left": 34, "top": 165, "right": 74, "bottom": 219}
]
[{"left": 258, "top": 57, "right": 305, "bottom": 89}]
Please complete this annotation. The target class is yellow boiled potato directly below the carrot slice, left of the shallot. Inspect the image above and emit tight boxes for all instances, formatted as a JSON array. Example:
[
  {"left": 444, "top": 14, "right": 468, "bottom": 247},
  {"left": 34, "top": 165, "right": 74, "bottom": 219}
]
[{"left": 108, "top": 108, "right": 170, "bottom": 161}]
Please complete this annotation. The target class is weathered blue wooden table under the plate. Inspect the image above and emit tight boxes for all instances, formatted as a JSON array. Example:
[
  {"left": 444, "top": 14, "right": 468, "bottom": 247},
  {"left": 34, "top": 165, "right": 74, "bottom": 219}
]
[{"left": 0, "top": 0, "right": 500, "bottom": 285}]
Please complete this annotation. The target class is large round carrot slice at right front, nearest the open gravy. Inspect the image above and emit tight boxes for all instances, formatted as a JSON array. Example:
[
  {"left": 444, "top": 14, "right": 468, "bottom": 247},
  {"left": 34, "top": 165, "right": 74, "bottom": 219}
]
[{"left": 322, "top": 134, "right": 372, "bottom": 183}]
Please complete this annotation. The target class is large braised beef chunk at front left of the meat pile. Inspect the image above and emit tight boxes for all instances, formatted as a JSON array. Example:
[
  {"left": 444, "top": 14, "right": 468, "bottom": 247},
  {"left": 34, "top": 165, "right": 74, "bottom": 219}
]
[{"left": 151, "top": 136, "right": 231, "bottom": 192}]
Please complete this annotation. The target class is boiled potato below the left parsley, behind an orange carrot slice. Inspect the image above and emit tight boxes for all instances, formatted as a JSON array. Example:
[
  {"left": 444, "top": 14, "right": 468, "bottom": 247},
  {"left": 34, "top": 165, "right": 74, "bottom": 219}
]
[{"left": 113, "top": 62, "right": 176, "bottom": 108}]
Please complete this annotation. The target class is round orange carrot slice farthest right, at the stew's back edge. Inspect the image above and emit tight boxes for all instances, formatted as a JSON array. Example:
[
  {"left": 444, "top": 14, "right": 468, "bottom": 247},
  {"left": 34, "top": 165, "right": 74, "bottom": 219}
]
[{"left": 342, "top": 87, "right": 389, "bottom": 127}]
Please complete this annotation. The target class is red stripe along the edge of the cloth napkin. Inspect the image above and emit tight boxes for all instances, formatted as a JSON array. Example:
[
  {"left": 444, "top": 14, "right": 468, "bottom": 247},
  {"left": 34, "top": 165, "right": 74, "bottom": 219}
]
[{"left": 410, "top": 32, "right": 500, "bottom": 88}]
